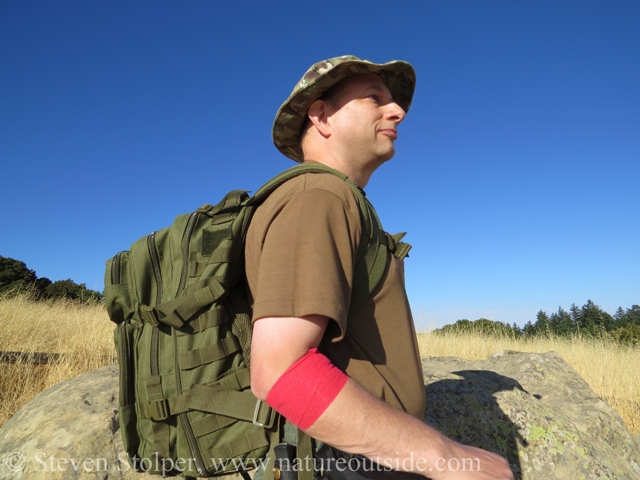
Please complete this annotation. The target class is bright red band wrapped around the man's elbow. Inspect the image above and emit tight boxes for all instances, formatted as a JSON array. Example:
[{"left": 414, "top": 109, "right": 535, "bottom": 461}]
[{"left": 266, "top": 348, "right": 349, "bottom": 430}]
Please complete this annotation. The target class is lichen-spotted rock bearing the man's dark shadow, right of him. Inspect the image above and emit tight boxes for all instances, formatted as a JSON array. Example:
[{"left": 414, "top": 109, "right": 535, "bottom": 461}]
[{"left": 422, "top": 351, "right": 640, "bottom": 480}]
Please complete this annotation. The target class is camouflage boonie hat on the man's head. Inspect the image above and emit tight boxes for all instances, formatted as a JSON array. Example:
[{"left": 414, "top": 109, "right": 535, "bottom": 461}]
[{"left": 272, "top": 55, "right": 416, "bottom": 162}]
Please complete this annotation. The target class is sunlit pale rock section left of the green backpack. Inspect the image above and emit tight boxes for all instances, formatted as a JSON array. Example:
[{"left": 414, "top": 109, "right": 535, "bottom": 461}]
[{"left": 0, "top": 366, "right": 162, "bottom": 480}]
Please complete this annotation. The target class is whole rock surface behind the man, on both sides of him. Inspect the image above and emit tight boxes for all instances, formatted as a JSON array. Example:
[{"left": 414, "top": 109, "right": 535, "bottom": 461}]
[{"left": 0, "top": 352, "right": 640, "bottom": 480}]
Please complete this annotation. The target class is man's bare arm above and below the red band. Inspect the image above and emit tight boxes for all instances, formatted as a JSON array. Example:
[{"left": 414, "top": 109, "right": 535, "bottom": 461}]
[{"left": 251, "top": 315, "right": 513, "bottom": 480}]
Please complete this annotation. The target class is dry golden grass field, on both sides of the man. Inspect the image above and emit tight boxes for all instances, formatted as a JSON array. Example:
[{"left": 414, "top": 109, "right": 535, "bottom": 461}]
[{"left": 0, "top": 296, "right": 640, "bottom": 435}]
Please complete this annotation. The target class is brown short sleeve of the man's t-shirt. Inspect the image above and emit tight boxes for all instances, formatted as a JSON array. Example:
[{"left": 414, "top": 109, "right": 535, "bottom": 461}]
[{"left": 247, "top": 178, "right": 361, "bottom": 339}]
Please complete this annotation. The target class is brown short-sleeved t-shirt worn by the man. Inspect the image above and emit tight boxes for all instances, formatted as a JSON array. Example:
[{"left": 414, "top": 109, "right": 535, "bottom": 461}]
[{"left": 245, "top": 173, "right": 425, "bottom": 418}]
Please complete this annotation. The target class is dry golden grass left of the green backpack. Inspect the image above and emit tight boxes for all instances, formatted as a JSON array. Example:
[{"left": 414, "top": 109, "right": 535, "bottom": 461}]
[{"left": 0, "top": 296, "right": 115, "bottom": 425}]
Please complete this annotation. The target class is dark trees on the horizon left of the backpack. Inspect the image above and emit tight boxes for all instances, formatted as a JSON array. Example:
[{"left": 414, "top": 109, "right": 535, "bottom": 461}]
[{"left": 0, "top": 256, "right": 103, "bottom": 302}]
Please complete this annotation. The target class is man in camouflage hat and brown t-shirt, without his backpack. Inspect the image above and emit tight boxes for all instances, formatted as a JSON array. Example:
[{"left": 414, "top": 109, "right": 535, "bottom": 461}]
[{"left": 245, "top": 56, "right": 513, "bottom": 479}]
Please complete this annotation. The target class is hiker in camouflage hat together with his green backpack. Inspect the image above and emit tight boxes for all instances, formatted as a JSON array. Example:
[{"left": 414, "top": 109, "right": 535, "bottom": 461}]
[{"left": 105, "top": 56, "right": 513, "bottom": 480}]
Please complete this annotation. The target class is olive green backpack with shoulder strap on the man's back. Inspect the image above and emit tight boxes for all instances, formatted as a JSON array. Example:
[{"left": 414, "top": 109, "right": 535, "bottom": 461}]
[{"left": 105, "top": 163, "right": 411, "bottom": 478}]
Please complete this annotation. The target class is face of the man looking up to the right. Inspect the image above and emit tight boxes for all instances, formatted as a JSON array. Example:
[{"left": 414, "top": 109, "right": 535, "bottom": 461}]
[{"left": 327, "top": 73, "right": 406, "bottom": 165}]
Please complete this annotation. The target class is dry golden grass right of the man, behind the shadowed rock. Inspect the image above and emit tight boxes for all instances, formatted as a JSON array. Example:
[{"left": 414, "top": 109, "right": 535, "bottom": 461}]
[{"left": 418, "top": 333, "right": 640, "bottom": 435}]
